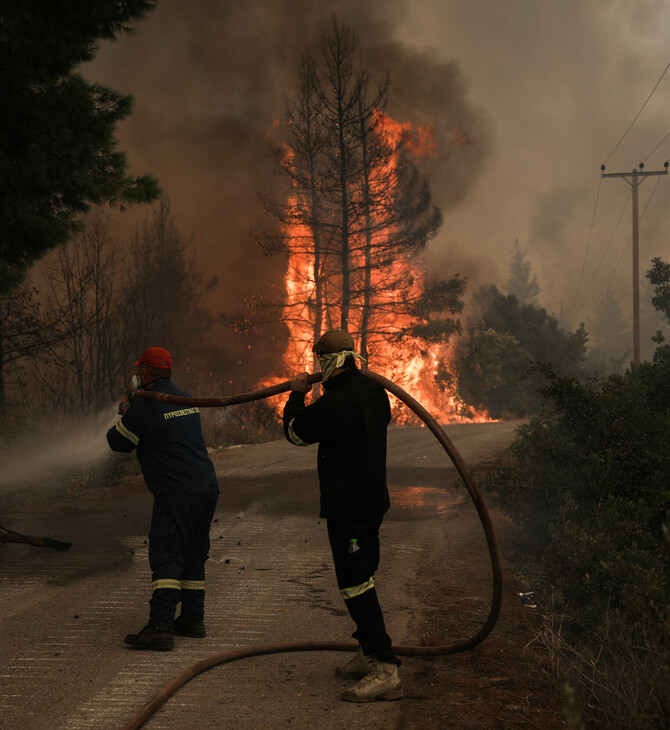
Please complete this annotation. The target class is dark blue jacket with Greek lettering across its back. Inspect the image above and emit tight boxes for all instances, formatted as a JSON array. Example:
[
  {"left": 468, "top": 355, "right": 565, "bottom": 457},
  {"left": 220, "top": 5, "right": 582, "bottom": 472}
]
[{"left": 107, "top": 380, "right": 218, "bottom": 497}]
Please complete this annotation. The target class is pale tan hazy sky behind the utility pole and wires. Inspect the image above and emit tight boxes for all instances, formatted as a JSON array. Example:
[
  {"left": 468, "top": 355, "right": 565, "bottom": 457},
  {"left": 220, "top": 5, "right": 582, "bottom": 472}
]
[{"left": 403, "top": 0, "right": 670, "bottom": 324}]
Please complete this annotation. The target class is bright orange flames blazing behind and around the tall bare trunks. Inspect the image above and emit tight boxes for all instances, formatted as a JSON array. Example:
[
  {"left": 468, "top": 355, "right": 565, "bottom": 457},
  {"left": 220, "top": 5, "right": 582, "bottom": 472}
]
[{"left": 262, "top": 113, "right": 491, "bottom": 423}]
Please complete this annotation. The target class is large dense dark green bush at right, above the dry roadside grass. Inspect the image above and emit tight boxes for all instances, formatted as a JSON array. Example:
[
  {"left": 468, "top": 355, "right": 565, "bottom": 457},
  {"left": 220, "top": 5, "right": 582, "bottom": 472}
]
[{"left": 497, "top": 348, "right": 670, "bottom": 635}]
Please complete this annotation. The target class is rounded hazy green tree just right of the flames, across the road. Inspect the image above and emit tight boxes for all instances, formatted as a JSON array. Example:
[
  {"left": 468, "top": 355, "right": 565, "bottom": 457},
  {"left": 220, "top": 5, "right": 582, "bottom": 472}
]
[{"left": 455, "top": 285, "right": 586, "bottom": 418}]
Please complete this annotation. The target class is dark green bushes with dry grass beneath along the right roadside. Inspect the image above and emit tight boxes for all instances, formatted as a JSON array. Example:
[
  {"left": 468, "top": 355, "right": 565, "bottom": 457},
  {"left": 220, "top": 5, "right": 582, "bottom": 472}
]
[{"left": 489, "top": 259, "right": 670, "bottom": 729}]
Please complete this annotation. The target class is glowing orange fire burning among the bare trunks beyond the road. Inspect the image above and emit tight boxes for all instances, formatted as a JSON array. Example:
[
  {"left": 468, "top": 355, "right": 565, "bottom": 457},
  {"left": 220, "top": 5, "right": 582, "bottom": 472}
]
[{"left": 261, "top": 113, "right": 490, "bottom": 423}]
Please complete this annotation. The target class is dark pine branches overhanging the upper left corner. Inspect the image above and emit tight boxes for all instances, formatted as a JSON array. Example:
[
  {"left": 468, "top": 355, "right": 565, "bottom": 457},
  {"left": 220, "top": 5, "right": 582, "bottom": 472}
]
[{"left": 0, "top": 0, "right": 159, "bottom": 293}]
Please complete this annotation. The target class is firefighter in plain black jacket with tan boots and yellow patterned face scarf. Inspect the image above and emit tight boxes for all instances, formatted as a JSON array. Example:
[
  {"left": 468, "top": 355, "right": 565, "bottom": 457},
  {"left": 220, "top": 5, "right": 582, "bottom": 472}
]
[{"left": 283, "top": 330, "right": 402, "bottom": 702}]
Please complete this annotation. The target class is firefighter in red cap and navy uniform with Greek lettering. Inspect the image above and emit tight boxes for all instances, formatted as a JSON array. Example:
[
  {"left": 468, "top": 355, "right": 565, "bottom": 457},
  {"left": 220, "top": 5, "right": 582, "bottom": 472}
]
[{"left": 107, "top": 347, "right": 219, "bottom": 651}]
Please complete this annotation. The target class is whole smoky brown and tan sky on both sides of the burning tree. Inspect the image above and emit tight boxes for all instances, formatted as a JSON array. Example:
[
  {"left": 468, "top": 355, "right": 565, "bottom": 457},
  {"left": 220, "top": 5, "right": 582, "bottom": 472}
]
[{"left": 85, "top": 0, "right": 670, "bottom": 364}]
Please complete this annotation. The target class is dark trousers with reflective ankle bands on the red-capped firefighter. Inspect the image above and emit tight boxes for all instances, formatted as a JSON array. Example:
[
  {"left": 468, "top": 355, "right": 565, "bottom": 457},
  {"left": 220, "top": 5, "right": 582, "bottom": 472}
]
[{"left": 149, "top": 491, "right": 219, "bottom": 627}]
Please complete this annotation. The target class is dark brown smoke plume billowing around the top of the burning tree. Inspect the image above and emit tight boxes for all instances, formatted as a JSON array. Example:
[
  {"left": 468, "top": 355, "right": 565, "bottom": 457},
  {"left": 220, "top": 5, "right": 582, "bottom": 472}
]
[{"left": 86, "top": 0, "right": 491, "bottom": 376}]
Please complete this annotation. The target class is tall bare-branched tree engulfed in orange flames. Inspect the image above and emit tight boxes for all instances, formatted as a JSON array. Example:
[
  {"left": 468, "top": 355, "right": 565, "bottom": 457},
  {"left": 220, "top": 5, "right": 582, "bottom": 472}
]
[{"left": 252, "top": 20, "right": 465, "bottom": 416}]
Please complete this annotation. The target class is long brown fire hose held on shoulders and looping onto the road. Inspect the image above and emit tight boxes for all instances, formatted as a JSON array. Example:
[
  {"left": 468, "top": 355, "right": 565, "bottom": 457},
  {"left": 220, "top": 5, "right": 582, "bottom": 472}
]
[{"left": 122, "top": 370, "right": 503, "bottom": 730}]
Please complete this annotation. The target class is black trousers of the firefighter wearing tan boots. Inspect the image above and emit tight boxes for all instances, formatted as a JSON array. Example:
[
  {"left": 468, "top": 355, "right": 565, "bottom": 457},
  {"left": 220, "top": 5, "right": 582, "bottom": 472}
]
[{"left": 327, "top": 519, "right": 400, "bottom": 665}]
